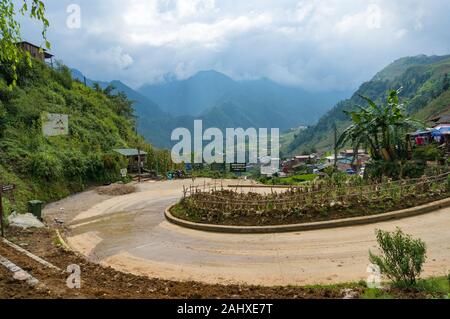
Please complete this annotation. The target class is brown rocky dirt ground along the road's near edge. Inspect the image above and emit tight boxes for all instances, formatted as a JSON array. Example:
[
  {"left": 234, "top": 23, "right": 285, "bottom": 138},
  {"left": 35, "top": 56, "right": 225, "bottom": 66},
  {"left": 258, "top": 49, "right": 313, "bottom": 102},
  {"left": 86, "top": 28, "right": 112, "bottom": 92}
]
[{"left": 0, "top": 229, "right": 363, "bottom": 299}]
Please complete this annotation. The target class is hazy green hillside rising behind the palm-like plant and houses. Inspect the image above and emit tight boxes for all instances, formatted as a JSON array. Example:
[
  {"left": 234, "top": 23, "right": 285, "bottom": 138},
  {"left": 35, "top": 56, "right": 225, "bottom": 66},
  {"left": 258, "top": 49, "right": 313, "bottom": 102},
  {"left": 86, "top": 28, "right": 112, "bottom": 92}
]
[{"left": 282, "top": 55, "right": 450, "bottom": 154}]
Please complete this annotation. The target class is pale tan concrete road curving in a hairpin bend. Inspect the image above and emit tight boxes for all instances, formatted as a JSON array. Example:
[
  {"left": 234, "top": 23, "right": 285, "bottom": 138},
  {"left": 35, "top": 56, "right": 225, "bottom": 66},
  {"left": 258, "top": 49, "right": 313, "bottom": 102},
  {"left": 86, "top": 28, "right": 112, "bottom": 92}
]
[{"left": 44, "top": 180, "right": 450, "bottom": 286}]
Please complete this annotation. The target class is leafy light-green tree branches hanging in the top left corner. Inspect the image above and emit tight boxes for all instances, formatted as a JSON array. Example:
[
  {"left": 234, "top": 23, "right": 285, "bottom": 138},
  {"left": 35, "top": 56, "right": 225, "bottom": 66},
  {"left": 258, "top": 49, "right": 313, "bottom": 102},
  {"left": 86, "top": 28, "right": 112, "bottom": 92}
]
[{"left": 0, "top": 0, "right": 50, "bottom": 87}]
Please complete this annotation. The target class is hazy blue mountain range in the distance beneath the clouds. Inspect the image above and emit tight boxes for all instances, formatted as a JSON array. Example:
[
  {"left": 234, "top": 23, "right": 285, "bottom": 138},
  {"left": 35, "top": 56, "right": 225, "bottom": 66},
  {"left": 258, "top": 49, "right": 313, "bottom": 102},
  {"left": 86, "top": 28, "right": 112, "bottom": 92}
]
[{"left": 72, "top": 70, "right": 350, "bottom": 148}]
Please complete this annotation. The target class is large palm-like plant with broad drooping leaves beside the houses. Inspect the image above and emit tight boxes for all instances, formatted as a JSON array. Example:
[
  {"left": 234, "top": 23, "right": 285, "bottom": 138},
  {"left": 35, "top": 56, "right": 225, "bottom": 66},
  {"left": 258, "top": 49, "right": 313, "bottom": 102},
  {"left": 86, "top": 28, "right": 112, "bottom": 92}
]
[{"left": 338, "top": 90, "right": 422, "bottom": 160}]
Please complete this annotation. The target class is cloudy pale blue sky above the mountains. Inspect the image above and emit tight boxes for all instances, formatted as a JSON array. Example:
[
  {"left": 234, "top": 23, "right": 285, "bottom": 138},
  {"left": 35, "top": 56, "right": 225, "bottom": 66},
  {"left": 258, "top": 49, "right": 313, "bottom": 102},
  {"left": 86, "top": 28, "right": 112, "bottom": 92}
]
[{"left": 22, "top": 0, "right": 450, "bottom": 91}]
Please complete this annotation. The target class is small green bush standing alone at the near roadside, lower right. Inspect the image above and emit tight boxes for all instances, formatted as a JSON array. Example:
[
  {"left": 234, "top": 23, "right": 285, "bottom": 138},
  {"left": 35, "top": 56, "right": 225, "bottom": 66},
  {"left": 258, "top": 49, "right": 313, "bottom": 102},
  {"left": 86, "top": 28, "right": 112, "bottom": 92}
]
[{"left": 370, "top": 228, "right": 426, "bottom": 287}]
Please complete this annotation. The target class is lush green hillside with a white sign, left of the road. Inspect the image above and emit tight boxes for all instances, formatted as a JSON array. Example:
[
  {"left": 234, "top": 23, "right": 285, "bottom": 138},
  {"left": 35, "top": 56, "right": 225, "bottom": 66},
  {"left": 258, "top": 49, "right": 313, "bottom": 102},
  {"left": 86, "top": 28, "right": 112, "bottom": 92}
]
[{"left": 0, "top": 61, "right": 171, "bottom": 218}]
